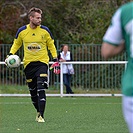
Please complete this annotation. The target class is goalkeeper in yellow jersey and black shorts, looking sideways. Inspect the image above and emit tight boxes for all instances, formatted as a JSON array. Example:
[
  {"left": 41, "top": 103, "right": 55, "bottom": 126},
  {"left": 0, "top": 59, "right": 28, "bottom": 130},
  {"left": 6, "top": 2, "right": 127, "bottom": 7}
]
[{"left": 6, "top": 7, "right": 57, "bottom": 122}]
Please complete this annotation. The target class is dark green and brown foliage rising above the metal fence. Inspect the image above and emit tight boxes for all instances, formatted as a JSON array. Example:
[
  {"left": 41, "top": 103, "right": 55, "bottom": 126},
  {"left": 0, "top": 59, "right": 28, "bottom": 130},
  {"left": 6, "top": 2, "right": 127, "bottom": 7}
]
[{"left": 0, "top": 0, "right": 130, "bottom": 44}]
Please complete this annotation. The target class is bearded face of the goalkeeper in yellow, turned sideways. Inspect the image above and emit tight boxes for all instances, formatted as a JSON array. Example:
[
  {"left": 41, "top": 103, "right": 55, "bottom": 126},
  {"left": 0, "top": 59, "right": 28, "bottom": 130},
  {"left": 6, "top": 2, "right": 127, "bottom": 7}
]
[{"left": 30, "top": 12, "right": 42, "bottom": 26}]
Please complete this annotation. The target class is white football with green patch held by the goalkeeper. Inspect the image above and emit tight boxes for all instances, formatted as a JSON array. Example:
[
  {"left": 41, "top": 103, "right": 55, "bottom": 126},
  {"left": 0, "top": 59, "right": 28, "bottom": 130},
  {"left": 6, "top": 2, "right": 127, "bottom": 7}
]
[{"left": 5, "top": 55, "right": 21, "bottom": 68}]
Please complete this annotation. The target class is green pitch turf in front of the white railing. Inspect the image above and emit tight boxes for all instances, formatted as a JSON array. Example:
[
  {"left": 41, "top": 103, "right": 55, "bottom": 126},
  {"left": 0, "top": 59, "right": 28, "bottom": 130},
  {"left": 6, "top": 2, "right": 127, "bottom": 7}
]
[{"left": 0, "top": 97, "right": 128, "bottom": 133}]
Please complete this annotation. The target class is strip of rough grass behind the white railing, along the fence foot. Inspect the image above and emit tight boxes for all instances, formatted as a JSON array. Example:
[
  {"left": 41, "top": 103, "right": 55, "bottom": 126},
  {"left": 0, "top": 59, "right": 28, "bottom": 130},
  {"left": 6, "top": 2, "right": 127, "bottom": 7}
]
[{"left": 0, "top": 84, "right": 121, "bottom": 94}]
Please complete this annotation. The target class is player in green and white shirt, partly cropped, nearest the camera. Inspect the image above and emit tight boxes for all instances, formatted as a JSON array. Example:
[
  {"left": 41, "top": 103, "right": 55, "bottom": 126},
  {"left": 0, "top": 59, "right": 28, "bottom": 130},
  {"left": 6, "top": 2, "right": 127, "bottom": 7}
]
[{"left": 101, "top": 2, "right": 133, "bottom": 133}]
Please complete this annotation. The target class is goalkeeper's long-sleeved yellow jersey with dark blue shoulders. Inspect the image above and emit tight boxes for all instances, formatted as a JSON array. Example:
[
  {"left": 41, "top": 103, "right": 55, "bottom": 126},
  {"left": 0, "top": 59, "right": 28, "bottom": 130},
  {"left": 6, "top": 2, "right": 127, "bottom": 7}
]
[{"left": 10, "top": 24, "right": 57, "bottom": 68}]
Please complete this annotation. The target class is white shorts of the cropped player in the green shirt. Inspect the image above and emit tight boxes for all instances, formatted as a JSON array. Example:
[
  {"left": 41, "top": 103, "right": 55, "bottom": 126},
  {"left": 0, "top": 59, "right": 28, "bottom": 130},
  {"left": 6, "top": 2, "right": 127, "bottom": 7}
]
[{"left": 122, "top": 96, "right": 133, "bottom": 133}]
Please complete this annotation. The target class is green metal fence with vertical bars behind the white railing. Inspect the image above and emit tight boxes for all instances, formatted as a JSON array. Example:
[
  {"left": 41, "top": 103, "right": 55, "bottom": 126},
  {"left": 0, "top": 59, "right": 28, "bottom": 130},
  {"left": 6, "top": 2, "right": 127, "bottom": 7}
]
[{"left": 0, "top": 44, "right": 126, "bottom": 92}]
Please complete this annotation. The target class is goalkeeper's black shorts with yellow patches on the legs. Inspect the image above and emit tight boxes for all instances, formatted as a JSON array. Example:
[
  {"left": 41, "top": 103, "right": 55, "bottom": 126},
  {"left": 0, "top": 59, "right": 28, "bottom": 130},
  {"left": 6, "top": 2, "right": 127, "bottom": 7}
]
[{"left": 24, "top": 62, "right": 48, "bottom": 88}]
